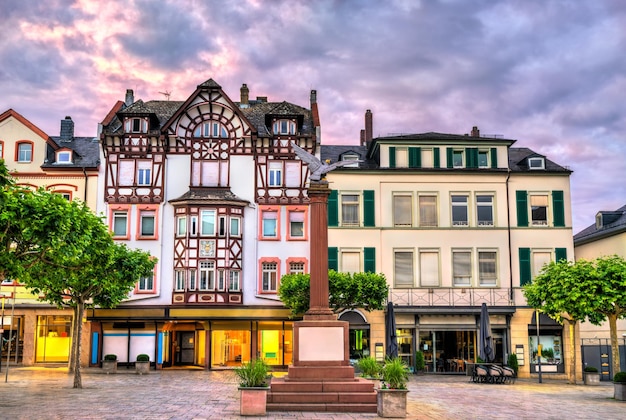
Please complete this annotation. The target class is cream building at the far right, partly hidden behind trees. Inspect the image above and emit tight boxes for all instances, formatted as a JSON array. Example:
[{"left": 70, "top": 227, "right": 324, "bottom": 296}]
[{"left": 574, "top": 206, "right": 626, "bottom": 380}]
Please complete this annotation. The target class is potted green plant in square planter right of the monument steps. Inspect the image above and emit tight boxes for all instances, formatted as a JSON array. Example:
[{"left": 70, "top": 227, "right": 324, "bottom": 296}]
[{"left": 376, "top": 357, "right": 409, "bottom": 417}]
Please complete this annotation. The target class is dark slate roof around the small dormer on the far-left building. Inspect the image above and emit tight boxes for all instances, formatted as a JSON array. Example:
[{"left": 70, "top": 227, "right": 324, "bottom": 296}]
[{"left": 41, "top": 137, "right": 100, "bottom": 169}]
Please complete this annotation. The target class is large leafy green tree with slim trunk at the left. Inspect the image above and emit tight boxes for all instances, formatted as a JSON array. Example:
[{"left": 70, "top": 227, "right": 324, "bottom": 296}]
[{"left": 0, "top": 162, "right": 156, "bottom": 388}]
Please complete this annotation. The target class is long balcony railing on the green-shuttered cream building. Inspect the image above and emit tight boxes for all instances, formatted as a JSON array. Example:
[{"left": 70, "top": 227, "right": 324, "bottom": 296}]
[{"left": 389, "top": 287, "right": 515, "bottom": 307}]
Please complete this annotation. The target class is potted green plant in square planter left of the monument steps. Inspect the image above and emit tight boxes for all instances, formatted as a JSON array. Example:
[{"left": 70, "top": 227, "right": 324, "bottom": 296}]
[{"left": 235, "top": 359, "right": 271, "bottom": 416}]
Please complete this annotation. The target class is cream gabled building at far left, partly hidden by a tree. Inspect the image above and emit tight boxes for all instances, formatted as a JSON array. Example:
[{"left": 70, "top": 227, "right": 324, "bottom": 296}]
[{"left": 0, "top": 109, "right": 100, "bottom": 365}]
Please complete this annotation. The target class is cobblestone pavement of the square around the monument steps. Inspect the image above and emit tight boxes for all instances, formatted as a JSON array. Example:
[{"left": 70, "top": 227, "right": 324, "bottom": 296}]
[{"left": 0, "top": 367, "right": 626, "bottom": 420}]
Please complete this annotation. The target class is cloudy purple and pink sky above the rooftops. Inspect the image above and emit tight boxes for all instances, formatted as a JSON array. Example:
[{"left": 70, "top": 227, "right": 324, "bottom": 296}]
[{"left": 0, "top": 0, "right": 626, "bottom": 233}]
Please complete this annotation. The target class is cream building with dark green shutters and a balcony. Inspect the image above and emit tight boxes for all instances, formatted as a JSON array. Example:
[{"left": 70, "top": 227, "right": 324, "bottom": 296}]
[{"left": 321, "top": 120, "right": 573, "bottom": 377}]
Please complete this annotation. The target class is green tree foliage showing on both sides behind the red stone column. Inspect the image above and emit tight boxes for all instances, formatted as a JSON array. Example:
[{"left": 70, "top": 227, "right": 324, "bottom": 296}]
[{"left": 278, "top": 270, "right": 389, "bottom": 316}]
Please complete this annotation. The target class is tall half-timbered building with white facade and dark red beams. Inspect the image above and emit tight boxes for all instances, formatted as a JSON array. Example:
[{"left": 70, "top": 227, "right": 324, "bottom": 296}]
[{"left": 90, "top": 80, "right": 320, "bottom": 368}]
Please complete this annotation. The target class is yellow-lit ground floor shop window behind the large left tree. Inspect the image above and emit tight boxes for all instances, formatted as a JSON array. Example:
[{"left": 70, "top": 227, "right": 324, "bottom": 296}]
[{"left": 35, "top": 315, "right": 72, "bottom": 363}]
